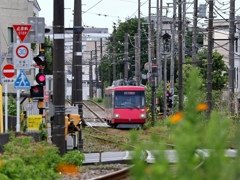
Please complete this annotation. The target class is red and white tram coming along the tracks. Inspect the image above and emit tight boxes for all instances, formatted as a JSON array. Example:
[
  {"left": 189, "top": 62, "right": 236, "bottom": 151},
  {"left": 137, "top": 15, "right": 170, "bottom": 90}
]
[{"left": 105, "top": 79, "right": 146, "bottom": 128}]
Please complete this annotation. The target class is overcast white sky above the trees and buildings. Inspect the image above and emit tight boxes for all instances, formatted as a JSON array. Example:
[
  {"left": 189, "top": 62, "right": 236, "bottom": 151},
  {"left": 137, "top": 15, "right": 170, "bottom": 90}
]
[{"left": 38, "top": 0, "right": 240, "bottom": 33}]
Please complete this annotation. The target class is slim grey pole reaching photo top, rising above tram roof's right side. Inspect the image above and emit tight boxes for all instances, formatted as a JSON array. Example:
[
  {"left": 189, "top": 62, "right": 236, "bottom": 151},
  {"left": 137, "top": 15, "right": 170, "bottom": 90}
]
[{"left": 135, "top": 0, "right": 141, "bottom": 85}]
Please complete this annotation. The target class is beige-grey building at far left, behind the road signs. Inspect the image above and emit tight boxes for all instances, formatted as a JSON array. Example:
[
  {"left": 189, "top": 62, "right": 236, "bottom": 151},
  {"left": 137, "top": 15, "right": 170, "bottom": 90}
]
[{"left": 0, "top": 0, "right": 41, "bottom": 93}]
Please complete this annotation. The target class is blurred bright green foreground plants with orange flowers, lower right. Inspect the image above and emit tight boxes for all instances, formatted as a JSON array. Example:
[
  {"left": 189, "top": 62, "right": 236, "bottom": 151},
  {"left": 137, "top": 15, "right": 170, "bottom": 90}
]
[{"left": 131, "top": 69, "right": 240, "bottom": 180}]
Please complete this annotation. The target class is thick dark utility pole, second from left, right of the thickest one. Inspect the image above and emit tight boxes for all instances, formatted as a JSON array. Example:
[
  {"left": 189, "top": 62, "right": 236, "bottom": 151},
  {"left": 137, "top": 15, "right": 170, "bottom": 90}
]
[{"left": 72, "top": 0, "right": 84, "bottom": 150}]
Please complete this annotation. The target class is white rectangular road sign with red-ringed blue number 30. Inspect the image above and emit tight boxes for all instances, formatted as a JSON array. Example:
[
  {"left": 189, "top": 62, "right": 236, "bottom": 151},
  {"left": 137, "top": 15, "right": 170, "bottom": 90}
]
[{"left": 13, "top": 43, "right": 32, "bottom": 69}]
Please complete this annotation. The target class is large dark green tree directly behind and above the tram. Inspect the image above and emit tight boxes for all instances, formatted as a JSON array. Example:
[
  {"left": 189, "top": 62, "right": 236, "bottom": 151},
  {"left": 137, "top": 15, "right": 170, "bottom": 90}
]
[{"left": 99, "top": 17, "right": 148, "bottom": 85}]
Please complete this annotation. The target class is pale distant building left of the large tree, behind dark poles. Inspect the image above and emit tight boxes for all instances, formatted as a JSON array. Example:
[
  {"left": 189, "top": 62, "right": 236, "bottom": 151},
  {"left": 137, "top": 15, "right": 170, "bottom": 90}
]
[{"left": 65, "top": 28, "right": 109, "bottom": 100}]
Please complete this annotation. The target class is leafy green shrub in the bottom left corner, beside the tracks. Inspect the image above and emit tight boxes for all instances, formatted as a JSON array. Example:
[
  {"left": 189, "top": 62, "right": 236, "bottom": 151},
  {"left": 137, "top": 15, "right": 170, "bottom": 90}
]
[{"left": 0, "top": 135, "right": 84, "bottom": 180}]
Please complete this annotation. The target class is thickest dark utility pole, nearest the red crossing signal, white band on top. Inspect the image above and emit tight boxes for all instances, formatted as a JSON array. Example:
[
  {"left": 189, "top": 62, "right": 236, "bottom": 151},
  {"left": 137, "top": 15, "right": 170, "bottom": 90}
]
[{"left": 52, "top": 0, "right": 66, "bottom": 155}]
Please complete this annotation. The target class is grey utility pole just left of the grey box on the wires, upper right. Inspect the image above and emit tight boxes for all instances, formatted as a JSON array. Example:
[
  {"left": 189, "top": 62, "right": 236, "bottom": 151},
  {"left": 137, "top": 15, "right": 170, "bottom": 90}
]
[{"left": 192, "top": 0, "right": 198, "bottom": 66}]
